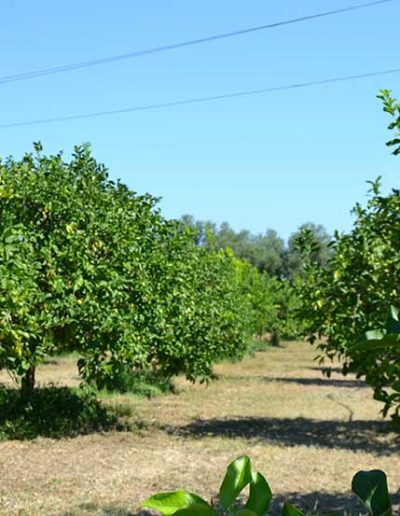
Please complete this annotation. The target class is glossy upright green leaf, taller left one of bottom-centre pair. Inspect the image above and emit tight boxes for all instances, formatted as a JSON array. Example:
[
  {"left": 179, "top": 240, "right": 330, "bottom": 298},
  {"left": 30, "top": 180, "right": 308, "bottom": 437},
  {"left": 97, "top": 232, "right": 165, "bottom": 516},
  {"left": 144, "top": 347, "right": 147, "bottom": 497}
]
[{"left": 219, "top": 455, "right": 251, "bottom": 510}]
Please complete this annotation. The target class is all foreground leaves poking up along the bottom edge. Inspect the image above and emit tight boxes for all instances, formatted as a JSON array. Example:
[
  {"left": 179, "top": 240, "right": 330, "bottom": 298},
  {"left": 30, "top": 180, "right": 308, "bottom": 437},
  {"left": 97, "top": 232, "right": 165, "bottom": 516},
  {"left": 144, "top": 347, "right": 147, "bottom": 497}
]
[{"left": 141, "top": 455, "right": 393, "bottom": 516}]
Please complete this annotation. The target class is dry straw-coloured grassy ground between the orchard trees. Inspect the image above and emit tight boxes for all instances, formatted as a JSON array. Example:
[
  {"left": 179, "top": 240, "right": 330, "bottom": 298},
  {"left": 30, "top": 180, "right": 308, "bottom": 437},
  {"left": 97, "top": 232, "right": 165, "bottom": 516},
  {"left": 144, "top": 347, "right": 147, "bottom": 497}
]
[{"left": 0, "top": 342, "right": 400, "bottom": 516}]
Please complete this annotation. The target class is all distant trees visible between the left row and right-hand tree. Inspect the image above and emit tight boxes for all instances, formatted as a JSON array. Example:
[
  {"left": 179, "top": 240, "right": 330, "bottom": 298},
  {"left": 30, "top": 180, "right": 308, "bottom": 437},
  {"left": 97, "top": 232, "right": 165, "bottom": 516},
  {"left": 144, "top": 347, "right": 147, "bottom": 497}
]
[{"left": 181, "top": 215, "right": 322, "bottom": 342}]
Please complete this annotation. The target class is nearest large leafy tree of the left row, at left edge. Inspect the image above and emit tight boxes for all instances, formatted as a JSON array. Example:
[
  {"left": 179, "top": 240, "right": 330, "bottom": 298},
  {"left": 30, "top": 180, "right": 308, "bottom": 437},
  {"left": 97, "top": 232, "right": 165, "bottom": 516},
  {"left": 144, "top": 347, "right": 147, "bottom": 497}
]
[{"left": 0, "top": 144, "right": 167, "bottom": 394}]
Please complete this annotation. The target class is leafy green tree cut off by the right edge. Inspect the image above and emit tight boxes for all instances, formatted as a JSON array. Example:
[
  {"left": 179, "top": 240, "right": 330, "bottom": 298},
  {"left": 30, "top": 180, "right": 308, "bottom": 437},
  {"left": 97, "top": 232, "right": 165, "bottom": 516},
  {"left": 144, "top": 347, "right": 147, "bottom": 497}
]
[{"left": 297, "top": 91, "right": 400, "bottom": 420}]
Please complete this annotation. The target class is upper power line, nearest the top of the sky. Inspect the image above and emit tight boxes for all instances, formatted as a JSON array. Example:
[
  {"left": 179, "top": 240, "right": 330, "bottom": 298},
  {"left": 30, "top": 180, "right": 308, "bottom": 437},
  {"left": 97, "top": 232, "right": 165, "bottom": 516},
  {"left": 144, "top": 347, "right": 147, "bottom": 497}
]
[{"left": 0, "top": 0, "right": 393, "bottom": 84}]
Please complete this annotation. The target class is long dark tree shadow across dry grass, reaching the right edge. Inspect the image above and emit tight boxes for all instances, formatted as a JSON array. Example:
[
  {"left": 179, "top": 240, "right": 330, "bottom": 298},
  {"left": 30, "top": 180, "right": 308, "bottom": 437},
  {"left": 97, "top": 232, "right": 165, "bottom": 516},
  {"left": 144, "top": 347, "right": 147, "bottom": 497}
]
[{"left": 166, "top": 417, "right": 400, "bottom": 455}]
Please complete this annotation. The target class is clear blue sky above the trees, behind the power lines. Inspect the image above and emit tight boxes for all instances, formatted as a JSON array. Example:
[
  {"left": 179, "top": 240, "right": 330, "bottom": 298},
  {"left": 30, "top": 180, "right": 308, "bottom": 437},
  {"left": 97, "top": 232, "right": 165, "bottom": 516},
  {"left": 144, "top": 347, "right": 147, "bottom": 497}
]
[{"left": 0, "top": 0, "right": 400, "bottom": 242}]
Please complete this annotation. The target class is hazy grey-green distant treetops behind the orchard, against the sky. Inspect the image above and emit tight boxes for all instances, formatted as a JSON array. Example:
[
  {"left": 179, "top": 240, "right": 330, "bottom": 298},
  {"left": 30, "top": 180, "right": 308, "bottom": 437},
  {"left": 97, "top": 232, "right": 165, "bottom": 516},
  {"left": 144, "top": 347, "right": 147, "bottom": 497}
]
[{"left": 181, "top": 215, "right": 332, "bottom": 279}]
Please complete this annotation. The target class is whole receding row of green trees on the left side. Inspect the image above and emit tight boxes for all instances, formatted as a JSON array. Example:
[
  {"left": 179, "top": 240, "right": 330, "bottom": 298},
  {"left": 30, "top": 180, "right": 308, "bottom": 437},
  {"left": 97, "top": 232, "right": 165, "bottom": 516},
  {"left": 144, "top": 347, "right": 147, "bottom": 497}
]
[{"left": 0, "top": 144, "right": 296, "bottom": 394}]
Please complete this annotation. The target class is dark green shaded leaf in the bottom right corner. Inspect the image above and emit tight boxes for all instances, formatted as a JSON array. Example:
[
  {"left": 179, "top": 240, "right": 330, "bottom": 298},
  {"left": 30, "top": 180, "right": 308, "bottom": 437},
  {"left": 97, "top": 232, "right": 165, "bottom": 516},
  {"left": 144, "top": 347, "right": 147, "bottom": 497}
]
[{"left": 351, "top": 469, "right": 392, "bottom": 516}]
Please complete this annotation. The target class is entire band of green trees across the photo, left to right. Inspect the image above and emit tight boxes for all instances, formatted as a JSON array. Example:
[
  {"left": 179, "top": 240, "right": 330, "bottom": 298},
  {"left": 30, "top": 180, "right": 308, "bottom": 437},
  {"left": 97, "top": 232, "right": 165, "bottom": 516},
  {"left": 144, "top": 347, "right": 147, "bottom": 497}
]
[{"left": 0, "top": 91, "right": 400, "bottom": 428}]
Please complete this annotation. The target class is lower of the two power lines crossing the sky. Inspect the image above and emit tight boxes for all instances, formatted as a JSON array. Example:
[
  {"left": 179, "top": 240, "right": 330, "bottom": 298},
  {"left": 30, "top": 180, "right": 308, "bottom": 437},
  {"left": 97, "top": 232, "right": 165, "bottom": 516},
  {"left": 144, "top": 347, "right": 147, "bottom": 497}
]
[{"left": 0, "top": 68, "right": 400, "bottom": 129}]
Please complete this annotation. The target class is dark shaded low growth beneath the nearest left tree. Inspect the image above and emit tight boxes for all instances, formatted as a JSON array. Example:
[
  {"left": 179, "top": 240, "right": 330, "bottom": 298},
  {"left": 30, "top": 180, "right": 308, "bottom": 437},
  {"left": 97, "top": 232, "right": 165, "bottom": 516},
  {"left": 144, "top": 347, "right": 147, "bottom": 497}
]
[{"left": 0, "top": 386, "right": 118, "bottom": 440}]
